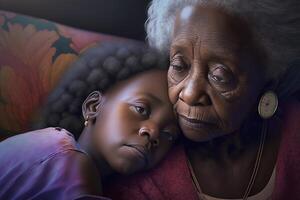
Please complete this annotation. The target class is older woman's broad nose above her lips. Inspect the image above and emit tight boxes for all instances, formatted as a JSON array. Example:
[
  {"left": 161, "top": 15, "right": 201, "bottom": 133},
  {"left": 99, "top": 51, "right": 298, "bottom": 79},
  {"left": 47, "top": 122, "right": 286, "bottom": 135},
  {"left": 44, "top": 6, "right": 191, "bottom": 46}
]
[{"left": 179, "top": 78, "right": 211, "bottom": 106}]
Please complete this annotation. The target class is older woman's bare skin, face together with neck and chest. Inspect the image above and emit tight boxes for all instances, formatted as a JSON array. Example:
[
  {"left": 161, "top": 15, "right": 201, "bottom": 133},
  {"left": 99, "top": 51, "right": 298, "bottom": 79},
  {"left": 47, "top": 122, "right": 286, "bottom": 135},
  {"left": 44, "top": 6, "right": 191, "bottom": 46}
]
[{"left": 168, "top": 6, "right": 280, "bottom": 198}]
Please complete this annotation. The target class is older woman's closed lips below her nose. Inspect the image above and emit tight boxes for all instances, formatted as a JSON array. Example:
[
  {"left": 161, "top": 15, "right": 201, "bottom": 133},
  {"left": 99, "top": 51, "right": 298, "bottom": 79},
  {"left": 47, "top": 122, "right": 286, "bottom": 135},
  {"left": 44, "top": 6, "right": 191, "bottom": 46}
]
[{"left": 178, "top": 115, "right": 216, "bottom": 130}]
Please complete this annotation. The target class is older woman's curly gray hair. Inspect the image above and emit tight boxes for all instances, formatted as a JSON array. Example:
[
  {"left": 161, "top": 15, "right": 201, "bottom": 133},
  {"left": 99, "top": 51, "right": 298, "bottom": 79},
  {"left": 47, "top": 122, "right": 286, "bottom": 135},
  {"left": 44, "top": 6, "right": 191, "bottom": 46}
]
[{"left": 145, "top": 0, "right": 300, "bottom": 78}]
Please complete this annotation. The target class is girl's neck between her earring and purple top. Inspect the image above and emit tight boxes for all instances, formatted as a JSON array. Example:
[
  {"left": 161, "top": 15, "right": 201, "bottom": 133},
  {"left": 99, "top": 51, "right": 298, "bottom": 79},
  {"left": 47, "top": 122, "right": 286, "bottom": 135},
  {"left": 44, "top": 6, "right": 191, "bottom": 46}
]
[{"left": 77, "top": 125, "right": 114, "bottom": 179}]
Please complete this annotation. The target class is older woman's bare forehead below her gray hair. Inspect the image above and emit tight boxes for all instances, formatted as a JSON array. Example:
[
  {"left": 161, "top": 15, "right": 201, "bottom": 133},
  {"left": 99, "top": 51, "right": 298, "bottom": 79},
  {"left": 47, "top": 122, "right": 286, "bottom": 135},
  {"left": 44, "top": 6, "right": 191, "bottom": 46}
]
[{"left": 172, "top": 6, "right": 249, "bottom": 54}]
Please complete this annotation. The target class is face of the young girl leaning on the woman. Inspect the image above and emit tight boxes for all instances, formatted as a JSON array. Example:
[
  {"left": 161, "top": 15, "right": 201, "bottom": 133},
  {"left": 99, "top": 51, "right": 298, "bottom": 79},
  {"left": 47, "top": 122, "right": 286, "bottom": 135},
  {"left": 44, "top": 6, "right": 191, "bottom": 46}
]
[{"left": 88, "top": 70, "right": 179, "bottom": 174}]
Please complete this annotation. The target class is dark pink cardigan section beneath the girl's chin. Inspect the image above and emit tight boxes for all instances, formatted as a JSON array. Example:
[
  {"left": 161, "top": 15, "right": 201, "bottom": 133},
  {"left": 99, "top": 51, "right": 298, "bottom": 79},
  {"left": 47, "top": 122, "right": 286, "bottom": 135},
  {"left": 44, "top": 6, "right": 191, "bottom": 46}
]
[{"left": 104, "top": 145, "right": 198, "bottom": 200}]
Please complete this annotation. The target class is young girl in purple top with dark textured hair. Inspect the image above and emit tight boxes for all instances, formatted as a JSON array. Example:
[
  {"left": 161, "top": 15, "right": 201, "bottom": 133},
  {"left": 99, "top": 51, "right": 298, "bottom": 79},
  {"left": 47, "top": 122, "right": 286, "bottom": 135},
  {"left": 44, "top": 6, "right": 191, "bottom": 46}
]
[{"left": 0, "top": 41, "right": 179, "bottom": 200}]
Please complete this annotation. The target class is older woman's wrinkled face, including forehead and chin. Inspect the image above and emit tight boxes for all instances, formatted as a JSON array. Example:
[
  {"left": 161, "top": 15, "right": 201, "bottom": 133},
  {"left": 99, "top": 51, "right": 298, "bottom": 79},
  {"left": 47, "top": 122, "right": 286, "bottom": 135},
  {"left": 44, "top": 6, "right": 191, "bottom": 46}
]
[{"left": 168, "top": 6, "right": 265, "bottom": 141}]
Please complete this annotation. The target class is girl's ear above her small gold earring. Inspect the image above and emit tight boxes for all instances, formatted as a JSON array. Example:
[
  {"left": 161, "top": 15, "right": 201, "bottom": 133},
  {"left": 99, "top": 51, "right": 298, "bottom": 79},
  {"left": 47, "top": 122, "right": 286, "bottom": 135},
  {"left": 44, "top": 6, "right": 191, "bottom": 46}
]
[{"left": 82, "top": 91, "right": 103, "bottom": 120}]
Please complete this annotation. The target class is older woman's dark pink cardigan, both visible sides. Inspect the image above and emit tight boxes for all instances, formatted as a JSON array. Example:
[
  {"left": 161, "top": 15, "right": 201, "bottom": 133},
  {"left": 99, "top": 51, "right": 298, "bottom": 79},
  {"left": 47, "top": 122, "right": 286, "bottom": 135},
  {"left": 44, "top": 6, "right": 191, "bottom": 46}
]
[{"left": 104, "top": 102, "right": 300, "bottom": 200}]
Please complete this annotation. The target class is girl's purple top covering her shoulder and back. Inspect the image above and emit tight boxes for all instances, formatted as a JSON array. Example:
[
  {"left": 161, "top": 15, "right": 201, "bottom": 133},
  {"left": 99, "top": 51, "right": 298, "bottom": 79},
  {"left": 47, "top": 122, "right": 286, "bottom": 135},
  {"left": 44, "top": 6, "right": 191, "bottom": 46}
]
[{"left": 0, "top": 128, "right": 107, "bottom": 200}]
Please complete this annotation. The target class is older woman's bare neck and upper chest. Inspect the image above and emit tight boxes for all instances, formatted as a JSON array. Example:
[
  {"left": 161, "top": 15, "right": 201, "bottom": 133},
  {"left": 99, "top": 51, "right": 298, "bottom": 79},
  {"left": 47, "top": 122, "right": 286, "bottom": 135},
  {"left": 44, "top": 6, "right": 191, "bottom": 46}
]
[{"left": 186, "top": 115, "right": 281, "bottom": 198}]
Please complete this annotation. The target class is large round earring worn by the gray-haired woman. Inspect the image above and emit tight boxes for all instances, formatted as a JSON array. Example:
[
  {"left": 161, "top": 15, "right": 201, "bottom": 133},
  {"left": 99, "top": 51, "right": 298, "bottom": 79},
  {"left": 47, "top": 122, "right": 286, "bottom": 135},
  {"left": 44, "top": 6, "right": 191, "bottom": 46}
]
[{"left": 258, "top": 90, "right": 278, "bottom": 119}]
